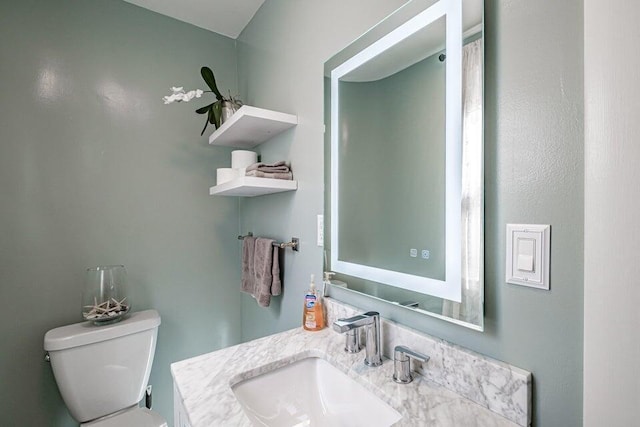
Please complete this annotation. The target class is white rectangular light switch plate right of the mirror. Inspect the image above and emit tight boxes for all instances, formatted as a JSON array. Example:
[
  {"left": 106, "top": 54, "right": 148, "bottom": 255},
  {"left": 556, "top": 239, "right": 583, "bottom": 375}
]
[{"left": 505, "top": 224, "right": 551, "bottom": 290}]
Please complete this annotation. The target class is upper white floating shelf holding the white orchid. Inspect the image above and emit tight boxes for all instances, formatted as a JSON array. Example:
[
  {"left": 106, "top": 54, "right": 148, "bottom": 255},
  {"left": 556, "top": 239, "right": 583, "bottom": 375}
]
[{"left": 209, "top": 105, "right": 298, "bottom": 148}]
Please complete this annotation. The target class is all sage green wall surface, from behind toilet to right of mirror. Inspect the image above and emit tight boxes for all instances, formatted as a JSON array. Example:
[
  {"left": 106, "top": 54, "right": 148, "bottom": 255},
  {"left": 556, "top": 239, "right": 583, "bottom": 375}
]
[{"left": 0, "top": 0, "right": 584, "bottom": 427}]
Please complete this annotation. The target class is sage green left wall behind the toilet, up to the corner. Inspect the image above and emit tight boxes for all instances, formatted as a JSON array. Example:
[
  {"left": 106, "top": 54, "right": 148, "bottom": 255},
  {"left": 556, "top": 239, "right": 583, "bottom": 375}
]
[{"left": 0, "top": 0, "right": 240, "bottom": 426}]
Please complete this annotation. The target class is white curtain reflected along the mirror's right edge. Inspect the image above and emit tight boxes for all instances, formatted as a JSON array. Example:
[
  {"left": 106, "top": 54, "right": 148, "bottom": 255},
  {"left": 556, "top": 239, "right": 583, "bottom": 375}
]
[{"left": 442, "top": 39, "right": 484, "bottom": 324}]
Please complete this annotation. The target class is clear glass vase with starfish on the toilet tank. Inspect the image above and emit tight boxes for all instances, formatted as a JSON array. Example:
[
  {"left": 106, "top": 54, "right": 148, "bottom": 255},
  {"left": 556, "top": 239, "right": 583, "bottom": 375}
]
[{"left": 82, "top": 265, "right": 131, "bottom": 324}]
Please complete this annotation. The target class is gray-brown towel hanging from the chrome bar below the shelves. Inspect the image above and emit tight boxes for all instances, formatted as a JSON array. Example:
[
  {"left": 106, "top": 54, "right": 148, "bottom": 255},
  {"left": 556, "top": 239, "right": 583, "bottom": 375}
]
[{"left": 242, "top": 236, "right": 282, "bottom": 307}]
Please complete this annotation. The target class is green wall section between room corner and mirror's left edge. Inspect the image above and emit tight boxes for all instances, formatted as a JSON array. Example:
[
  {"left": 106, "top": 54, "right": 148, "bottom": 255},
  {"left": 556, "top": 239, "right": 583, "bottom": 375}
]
[{"left": 238, "top": 0, "right": 403, "bottom": 340}]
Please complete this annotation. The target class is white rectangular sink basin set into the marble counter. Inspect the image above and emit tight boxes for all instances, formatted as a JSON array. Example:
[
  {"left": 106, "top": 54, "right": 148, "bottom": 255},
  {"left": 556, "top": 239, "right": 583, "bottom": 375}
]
[{"left": 231, "top": 357, "right": 402, "bottom": 427}]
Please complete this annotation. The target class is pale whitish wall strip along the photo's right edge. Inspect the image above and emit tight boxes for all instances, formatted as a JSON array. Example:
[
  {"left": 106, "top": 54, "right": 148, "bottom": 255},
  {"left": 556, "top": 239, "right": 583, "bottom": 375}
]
[{"left": 584, "top": 0, "right": 640, "bottom": 427}]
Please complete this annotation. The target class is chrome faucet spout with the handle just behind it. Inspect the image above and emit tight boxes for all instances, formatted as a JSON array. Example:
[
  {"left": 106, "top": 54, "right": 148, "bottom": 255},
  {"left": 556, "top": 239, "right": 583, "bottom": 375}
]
[{"left": 333, "top": 311, "right": 382, "bottom": 366}]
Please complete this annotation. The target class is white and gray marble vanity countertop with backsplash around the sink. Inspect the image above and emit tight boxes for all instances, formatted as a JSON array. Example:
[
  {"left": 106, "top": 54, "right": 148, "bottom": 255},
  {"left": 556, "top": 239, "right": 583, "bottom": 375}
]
[{"left": 171, "top": 298, "right": 531, "bottom": 427}]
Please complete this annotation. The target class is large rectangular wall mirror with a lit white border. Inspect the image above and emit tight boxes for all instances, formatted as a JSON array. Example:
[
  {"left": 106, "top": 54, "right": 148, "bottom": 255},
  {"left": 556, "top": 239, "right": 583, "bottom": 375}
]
[{"left": 325, "top": 0, "right": 484, "bottom": 330}]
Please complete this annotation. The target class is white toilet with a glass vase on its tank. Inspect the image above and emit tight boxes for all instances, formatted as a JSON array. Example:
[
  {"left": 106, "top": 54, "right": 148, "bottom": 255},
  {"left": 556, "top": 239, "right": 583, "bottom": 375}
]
[{"left": 44, "top": 310, "right": 167, "bottom": 427}]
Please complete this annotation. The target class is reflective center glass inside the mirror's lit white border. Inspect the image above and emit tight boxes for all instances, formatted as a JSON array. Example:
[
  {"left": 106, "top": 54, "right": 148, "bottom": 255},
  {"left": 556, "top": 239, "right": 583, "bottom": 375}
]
[{"left": 336, "top": 17, "right": 446, "bottom": 281}]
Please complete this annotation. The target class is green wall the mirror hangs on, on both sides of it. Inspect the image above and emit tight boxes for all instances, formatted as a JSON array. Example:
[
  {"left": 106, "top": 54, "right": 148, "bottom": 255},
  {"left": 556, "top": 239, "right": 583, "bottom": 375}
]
[{"left": 238, "top": 0, "right": 584, "bottom": 427}]
